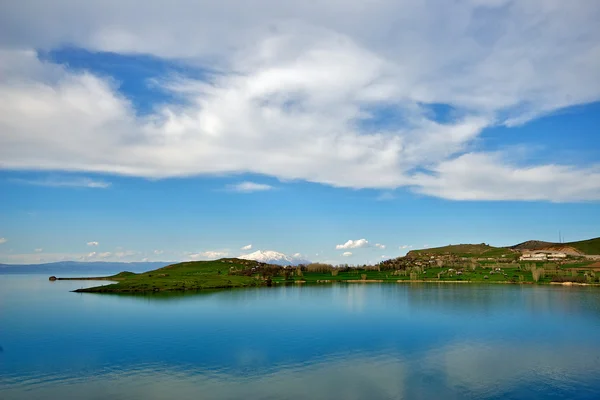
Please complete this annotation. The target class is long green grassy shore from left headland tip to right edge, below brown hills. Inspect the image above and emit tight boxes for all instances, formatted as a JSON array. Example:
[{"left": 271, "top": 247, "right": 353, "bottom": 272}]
[{"left": 64, "top": 259, "right": 600, "bottom": 293}]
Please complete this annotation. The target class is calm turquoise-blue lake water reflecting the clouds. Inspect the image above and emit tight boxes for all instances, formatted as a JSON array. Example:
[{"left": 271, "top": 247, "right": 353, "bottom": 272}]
[{"left": 0, "top": 275, "right": 600, "bottom": 400}]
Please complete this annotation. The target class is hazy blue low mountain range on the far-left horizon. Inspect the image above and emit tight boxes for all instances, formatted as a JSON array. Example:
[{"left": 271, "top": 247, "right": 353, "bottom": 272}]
[{"left": 0, "top": 261, "right": 172, "bottom": 275}]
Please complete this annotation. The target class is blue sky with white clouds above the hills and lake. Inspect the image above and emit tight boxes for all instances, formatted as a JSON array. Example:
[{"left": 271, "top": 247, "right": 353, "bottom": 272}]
[{"left": 0, "top": 0, "right": 600, "bottom": 264}]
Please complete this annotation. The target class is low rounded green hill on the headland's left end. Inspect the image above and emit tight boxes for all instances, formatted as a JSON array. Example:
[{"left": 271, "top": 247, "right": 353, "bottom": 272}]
[{"left": 77, "top": 258, "right": 268, "bottom": 293}]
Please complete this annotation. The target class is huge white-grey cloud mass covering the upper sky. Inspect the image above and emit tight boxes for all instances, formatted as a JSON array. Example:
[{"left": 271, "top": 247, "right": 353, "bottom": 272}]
[{"left": 0, "top": 0, "right": 600, "bottom": 201}]
